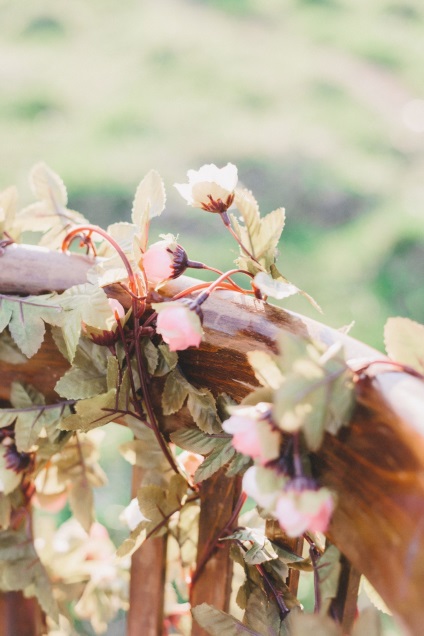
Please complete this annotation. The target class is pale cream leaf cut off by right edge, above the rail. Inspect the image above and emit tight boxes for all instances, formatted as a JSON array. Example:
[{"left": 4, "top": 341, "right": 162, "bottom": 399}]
[{"left": 384, "top": 318, "right": 424, "bottom": 374}]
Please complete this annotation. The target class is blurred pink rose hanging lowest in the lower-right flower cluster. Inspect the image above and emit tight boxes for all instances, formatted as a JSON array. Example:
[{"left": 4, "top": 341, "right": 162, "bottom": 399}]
[{"left": 275, "top": 488, "right": 334, "bottom": 537}]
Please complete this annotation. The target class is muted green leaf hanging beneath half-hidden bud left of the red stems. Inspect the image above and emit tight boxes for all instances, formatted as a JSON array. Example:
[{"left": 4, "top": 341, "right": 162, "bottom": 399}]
[{"left": 55, "top": 338, "right": 109, "bottom": 400}]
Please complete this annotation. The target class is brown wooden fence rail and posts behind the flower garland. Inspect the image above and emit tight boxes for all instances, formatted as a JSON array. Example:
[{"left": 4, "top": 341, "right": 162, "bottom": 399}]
[{"left": 0, "top": 245, "right": 424, "bottom": 636}]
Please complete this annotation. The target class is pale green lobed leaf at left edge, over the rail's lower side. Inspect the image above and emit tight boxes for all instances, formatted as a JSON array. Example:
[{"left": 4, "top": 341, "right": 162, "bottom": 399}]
[{"left": 0, "top": 294, "right": 61, "bottom": 358}]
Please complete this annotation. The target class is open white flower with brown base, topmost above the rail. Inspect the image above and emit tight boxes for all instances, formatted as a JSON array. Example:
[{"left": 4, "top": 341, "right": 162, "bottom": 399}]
[{"left": 174, "top": 163, "right": 238, "bottom": 212}]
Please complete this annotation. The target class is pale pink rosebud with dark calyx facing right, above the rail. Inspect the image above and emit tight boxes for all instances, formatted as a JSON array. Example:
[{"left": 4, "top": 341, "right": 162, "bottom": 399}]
[{"left": 140, "top": 238, "right": 187, "bottom": 285}]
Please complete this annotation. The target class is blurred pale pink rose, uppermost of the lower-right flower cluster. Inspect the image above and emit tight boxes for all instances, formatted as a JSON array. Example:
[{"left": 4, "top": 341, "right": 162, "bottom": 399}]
[{"left": 222, "top": 402, "right": 281, "bottom": 464}]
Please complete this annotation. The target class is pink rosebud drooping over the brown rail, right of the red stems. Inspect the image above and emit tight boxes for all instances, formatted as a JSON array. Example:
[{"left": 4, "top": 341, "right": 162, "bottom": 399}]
[{"left": 152, "top": 302, "right": 203, "bottom": 351}]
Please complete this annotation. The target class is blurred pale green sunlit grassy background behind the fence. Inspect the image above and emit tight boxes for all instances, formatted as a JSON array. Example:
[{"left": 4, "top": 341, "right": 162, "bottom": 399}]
[{"left": 0, "top": 0, "right": 424, "bottom": 632}]
